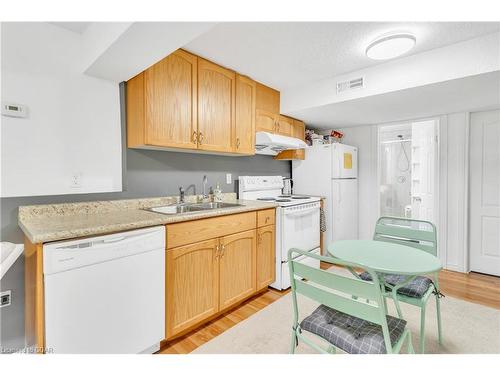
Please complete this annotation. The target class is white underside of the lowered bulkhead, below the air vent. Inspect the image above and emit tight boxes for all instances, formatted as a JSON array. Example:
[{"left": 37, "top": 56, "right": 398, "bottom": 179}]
[{"left": 290, "top": 71, "right": 500, "bottom": 129}]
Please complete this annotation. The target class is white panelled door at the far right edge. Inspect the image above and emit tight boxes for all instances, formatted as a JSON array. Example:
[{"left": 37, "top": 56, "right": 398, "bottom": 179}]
[{"left": 469, "top": 111, "right": 500, "bottom": 276}]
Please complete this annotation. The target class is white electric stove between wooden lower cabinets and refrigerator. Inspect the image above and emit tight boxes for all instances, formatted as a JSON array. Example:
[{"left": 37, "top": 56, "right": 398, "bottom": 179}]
[{"left": 238, "top": 176, "right": 321, "bottom": 290}]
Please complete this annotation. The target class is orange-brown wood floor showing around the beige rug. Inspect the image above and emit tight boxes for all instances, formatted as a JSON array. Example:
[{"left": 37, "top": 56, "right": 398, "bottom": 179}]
[{"left": 159, "top": 271, "right": 500, "bottom": 354}]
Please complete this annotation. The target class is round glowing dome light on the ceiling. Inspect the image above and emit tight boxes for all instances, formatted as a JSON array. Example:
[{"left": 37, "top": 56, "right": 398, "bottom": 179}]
[{"left": 366, "top": 33, "right": 417, "bottom": 60}]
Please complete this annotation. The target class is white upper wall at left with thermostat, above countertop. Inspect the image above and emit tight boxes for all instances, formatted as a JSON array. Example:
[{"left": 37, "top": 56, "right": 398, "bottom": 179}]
[{"left": 1, "top": 22, "right": 122, "bottom": 197}]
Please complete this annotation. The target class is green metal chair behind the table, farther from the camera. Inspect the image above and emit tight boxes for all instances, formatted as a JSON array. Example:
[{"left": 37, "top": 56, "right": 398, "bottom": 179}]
[{"left": 359, "top": 216, "right": 442, "bottom": 353}]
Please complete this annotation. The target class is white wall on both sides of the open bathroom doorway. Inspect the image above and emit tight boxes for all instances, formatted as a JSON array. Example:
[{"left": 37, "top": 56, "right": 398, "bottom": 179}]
[{"left": 341, "top": 113, "right": 469, "bottom": 272}]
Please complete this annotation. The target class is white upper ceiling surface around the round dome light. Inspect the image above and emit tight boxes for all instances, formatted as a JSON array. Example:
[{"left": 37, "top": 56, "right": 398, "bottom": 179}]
[{"left": 184, "top": 22, "right": 500, "bottom": 90}]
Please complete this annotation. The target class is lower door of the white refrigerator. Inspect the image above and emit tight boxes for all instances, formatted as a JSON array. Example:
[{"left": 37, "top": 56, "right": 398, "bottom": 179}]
[{"left": 326, "top": 179, "right": 358, "bottom": 245}]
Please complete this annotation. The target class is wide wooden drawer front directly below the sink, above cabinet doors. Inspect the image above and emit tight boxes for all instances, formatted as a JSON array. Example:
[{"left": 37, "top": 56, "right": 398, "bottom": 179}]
[{"left": 167, "top": 212, "right": 257, "bottom": 249}]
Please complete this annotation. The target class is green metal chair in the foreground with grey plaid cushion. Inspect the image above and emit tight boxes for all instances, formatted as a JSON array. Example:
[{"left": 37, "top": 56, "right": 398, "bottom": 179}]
[{"left": 288, "top": 249, "right": 414, "bottom": 354}]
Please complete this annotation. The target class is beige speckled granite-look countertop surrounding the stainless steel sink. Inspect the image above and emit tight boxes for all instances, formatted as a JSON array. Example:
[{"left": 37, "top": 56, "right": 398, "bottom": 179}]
[{"left": 18, "top": 193, "right": 277, "bottom": 243}]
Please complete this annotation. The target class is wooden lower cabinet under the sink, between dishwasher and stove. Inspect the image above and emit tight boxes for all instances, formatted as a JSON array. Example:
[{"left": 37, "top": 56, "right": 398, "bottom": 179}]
[{"left": 165, "top": 209, "right": 275, "bottom": 340}]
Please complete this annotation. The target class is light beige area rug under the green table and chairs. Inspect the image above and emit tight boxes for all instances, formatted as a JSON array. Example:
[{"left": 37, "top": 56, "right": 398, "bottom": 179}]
[{"left": 193, "top": 270, "right": 500, "bottom": 354}]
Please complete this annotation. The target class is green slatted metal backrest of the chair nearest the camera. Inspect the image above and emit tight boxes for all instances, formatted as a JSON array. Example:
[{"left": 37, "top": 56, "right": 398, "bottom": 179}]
[{"left": 288, "top": 249, "right": 392, "bottom": 353}]
